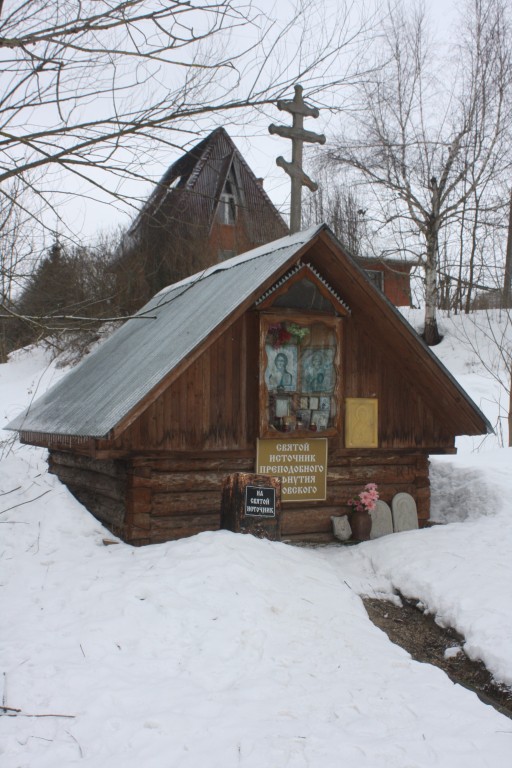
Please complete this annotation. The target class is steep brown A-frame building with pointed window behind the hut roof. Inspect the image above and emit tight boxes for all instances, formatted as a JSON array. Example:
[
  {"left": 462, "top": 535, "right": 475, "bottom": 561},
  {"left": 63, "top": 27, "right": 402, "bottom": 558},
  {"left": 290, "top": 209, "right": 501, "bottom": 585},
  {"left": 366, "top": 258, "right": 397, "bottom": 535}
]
[{"left": 115, "top": 128, "right": 288, "bottom": 313}]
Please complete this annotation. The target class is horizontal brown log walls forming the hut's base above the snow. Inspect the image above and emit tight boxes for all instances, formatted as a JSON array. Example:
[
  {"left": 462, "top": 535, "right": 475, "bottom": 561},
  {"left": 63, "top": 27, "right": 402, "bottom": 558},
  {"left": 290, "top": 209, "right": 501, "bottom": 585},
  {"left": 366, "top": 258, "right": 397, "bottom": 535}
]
[{"left": 51, "top": 452, "right": 430, "bottom": 545}]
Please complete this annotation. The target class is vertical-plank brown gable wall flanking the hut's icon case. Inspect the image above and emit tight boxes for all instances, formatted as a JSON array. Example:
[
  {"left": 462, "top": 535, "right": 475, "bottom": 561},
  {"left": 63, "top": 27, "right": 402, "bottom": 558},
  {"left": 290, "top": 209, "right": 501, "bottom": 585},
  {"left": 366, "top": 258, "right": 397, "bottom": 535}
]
[{"left": 105, "top": 300, "right": 455, "bottom": 454}]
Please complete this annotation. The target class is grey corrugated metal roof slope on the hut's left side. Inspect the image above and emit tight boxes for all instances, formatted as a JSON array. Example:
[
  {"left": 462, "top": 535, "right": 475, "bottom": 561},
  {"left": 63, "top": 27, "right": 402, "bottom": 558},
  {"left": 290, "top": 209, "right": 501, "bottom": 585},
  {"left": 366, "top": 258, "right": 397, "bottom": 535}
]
[{"left": 8, "top": 227, "right": 322, "bottom": 437}]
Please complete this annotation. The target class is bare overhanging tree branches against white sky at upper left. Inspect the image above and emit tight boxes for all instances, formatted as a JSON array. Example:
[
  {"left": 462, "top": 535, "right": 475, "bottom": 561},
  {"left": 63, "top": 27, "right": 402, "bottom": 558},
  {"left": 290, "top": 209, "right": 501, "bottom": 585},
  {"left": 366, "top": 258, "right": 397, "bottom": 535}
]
[{"left": 0, "top": 0, "right": 374, "bottom": 230}]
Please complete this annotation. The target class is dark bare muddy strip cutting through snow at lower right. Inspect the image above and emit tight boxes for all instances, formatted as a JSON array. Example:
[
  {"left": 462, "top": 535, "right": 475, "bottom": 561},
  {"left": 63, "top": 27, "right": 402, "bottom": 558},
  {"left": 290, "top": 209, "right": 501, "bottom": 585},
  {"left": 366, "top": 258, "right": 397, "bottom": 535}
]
[{"left": 364, "top": 596, "right": 512, "bottom": 718}]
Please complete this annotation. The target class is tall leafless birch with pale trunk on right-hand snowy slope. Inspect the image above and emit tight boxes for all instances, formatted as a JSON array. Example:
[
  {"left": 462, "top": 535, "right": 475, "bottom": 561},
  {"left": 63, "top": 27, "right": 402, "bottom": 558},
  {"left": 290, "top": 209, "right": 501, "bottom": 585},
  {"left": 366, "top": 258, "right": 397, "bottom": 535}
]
[{"left": 329, "top": 0, "right": 512, "bottom": 345}]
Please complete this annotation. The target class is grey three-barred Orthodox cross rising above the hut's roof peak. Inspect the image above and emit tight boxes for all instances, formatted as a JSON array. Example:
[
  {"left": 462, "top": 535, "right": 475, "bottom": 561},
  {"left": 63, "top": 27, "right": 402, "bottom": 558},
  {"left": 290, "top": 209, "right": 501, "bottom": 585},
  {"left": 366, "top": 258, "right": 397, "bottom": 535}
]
[{"left": 268, "top": 85, "right": 325, "bottom": 234}]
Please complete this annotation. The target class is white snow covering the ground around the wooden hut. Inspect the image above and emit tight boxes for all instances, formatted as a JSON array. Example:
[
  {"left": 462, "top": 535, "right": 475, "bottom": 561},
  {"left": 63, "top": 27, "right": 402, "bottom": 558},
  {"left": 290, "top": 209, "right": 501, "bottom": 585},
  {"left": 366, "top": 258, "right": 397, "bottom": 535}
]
[{"left": 0, "top": 313, "right": 512, "bottom": 768}]
